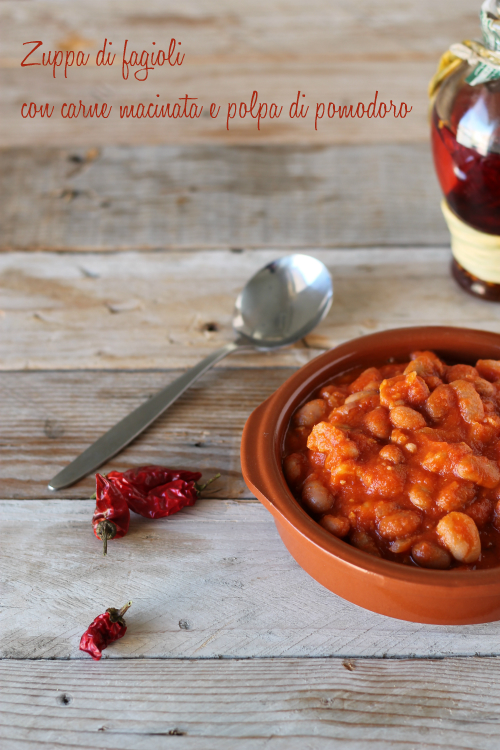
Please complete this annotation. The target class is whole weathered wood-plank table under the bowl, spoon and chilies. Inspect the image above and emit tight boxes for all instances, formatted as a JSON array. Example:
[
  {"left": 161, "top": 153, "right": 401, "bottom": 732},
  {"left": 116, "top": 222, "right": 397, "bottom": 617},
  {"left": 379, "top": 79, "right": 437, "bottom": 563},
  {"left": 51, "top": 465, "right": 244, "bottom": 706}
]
[{"left": 0, "top": 0, "right": 500, "bottom": 750}]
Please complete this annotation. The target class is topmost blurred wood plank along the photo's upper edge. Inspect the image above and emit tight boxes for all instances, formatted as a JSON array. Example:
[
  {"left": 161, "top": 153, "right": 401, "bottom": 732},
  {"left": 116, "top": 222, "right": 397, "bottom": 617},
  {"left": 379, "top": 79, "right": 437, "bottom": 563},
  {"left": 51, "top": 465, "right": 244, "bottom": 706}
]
[{"left": 0, "top": 0, "right": 479, "bottom": 64}]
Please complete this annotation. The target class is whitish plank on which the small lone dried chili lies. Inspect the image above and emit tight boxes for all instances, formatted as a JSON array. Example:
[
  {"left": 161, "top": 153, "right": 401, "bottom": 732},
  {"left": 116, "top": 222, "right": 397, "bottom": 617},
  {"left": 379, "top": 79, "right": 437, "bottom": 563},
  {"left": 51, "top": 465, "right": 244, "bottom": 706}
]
[{"left": 0, "top": 500, "right": 500, "bottom": 660}]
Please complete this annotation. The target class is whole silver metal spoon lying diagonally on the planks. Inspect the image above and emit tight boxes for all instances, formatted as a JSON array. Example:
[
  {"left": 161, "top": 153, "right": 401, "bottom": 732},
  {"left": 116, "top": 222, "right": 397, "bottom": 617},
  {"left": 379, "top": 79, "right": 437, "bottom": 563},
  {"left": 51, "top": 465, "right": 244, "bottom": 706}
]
[{"left": 49, "top": 255, "right": 333, "bottom": 490}]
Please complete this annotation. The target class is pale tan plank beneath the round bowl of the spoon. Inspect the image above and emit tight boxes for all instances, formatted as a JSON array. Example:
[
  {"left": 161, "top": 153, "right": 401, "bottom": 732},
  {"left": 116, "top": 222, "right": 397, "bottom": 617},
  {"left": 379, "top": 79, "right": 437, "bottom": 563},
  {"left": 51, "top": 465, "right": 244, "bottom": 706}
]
[{"left": 0, "top": 249, "right": 500, "bottom": 370}]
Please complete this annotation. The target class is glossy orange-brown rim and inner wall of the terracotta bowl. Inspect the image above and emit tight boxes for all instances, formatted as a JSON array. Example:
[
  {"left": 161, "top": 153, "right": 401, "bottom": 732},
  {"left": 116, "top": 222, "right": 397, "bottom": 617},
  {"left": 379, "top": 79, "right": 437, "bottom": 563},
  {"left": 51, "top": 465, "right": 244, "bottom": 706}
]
[{"left": 241, "top": 326, "right": 500, "bottom": 593}]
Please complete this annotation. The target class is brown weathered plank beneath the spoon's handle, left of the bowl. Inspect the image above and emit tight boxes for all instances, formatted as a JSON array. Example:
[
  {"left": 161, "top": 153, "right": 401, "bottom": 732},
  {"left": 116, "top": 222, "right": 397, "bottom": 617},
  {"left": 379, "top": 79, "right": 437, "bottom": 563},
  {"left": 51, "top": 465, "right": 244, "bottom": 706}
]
[{"left": 0, "top": 368, "right": 293, "bottom": 499}]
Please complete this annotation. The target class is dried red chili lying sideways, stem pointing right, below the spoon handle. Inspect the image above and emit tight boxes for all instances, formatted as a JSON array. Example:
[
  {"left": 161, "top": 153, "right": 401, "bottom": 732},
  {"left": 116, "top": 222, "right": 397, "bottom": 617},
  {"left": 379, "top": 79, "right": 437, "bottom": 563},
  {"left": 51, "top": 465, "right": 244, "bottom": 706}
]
[{"left": 107, "top": 466, "right": 220, "bottom": 518}]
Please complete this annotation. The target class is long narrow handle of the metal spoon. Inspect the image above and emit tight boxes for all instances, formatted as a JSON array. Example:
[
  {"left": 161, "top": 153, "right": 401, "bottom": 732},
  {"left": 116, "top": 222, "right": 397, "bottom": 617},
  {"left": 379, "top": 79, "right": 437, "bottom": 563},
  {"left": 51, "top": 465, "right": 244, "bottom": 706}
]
[{"left": 49, "top": 340, "right": 248, "bottom": 490}]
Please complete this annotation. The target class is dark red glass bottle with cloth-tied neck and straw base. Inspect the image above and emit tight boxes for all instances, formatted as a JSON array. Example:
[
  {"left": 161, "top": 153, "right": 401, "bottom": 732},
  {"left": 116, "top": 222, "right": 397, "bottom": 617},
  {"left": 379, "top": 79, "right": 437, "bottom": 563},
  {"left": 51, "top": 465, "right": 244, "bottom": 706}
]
[{"left": 431, "top": 0, "right": 500, "bottom": 301}]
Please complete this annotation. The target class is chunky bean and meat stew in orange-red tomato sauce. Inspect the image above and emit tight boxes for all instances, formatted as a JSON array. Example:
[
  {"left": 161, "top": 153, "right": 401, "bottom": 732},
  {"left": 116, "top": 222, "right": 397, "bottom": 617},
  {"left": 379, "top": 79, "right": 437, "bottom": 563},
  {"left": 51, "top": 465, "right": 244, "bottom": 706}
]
[{"left": 283, "top": 352, "right": 500, "bottom": 570}]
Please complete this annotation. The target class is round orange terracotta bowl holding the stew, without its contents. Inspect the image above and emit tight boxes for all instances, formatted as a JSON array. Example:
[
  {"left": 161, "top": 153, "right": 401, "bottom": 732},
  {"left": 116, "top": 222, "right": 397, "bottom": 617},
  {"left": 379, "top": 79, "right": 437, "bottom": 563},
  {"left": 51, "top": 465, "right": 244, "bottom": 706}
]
[{"left": 241, "top": 327, "right": 500, "bottom": 625}]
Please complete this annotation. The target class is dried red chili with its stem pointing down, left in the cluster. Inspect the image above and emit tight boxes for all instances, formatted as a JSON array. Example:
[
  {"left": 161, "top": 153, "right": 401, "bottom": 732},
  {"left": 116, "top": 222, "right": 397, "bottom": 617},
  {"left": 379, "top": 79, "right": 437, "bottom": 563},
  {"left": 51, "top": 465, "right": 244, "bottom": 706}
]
[{"left": 92, "top": 474, "right": 130, "bottom": 555}]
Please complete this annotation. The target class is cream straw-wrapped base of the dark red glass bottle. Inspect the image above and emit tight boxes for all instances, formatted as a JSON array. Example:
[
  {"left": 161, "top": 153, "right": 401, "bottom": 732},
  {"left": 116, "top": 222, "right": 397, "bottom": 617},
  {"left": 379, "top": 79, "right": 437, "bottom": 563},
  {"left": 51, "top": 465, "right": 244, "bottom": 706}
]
[{"left": 441, "top": 199, "right": 500, "bottom": 302}]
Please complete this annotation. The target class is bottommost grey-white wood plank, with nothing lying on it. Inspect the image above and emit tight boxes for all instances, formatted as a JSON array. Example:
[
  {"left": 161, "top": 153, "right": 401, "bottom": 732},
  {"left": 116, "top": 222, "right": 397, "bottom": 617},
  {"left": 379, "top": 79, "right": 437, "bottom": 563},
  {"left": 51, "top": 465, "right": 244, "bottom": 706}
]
[{"left": 0, "top": 659, "right": 500, "bottom": 750}]
